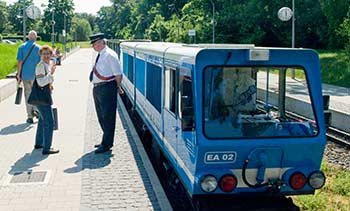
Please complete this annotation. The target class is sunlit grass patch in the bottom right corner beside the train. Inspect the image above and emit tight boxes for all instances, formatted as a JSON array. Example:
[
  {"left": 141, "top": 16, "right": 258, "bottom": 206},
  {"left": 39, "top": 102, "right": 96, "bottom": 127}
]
[{"left": 292, "top": 162, "right": 350, "bottom": 211}]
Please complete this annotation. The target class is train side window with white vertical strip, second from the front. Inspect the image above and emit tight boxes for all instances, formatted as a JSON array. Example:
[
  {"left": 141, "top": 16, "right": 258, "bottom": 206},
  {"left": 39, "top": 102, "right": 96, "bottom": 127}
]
[{"left": 165, "top": 67, "right": 178, "bottom": 114}]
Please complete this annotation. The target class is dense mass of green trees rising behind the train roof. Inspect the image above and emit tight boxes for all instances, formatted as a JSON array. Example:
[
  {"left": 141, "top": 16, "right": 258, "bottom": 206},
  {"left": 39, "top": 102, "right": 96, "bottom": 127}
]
[{"left": 94, "top": 0, "right": 350, "bottom": 48}]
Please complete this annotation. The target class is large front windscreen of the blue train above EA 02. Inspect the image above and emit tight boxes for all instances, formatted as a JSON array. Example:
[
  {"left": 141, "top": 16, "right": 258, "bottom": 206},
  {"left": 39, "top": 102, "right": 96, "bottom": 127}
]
[{"left": 203, "top": 66, "right": 318, "bottom": 139}]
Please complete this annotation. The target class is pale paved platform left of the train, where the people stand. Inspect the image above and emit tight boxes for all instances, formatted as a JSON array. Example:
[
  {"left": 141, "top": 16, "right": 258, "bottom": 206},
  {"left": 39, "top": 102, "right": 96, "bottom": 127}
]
[{"left": 0, "top": 49, "right": 171, "bottom": 211}]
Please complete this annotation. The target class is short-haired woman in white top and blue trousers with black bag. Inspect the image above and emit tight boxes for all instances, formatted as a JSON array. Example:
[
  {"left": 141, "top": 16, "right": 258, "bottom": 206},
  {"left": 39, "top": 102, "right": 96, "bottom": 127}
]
[{"left": 28, "top": 45, "right": 59, "bottom": 155}]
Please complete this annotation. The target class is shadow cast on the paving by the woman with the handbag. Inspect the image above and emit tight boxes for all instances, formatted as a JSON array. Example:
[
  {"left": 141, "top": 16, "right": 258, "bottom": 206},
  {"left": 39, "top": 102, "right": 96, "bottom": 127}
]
[{"left": 9, "top": 150, "right": 48, "bottom": 175}]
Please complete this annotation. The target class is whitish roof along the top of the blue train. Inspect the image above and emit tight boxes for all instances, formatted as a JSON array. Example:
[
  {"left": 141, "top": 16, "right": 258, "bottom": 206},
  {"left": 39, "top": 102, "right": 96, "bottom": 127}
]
[{"left": 120, "top": 41, "right": 312, "bottom": 64}]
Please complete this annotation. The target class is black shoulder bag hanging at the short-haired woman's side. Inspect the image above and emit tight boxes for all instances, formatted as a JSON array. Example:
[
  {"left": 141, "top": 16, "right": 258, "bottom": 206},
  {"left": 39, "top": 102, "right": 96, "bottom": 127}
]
[{"left": 28, "top": 79, "right": 52, "bottom": 106}]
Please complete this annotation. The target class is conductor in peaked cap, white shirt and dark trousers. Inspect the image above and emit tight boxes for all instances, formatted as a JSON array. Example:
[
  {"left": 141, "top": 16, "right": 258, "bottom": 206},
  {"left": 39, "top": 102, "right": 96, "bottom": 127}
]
[{"left": 90, "top": 33, "right": 123, "bottom": 153}]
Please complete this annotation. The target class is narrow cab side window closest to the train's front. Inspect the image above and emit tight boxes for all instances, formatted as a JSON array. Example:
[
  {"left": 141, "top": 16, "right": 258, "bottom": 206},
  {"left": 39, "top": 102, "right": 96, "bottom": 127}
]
[{"left": 179, "top": 69, "right": 195, "bottom": 131}]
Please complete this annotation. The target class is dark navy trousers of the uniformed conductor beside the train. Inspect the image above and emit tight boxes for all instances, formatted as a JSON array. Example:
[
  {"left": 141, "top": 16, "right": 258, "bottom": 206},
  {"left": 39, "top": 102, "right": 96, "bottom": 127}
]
[{"left": 93, "top": 80, "right": 118, "bottom": 148}]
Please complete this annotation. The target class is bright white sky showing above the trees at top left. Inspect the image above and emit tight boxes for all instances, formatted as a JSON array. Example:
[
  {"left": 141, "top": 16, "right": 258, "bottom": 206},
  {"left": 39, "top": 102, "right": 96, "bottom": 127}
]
[{"left": 5, "top": 0, "right": 111, "bottom": 15}]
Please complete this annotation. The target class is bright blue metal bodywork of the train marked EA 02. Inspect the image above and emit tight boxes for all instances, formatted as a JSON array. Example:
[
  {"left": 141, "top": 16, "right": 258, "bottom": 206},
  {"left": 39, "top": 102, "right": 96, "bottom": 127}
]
[{"left": 122, "top": 42, "right": 326, "bottom": 195}]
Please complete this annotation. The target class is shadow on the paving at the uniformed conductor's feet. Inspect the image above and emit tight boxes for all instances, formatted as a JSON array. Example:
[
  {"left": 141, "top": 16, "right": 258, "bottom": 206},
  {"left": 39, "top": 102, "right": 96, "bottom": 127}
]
[{"left": 64, "top": 151, "right": 113, "bottom": 174}]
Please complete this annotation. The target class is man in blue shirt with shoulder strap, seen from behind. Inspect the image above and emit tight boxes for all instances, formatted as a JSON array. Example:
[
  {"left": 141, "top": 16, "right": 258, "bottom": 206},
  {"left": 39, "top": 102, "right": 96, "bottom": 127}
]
[{"left": 17, "top": 30, "right": 40, "bottom": 124}]
